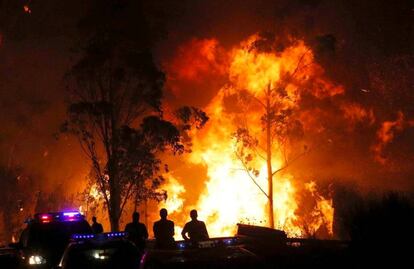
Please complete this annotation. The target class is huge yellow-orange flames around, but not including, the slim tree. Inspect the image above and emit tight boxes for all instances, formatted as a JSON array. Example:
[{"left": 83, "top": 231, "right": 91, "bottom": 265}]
[{"left": 161, "top": 35, "right": 344, "bottom": 236}]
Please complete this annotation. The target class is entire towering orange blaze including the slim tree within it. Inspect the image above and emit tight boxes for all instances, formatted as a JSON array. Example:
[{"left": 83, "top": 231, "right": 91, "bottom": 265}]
[{"left": 154, "top": 35, "right": 344, "bottom": 237}]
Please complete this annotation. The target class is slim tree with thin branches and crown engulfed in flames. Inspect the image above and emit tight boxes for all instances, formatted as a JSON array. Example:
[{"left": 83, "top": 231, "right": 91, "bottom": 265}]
[{"left": 230, "top": 35, "right": 340, "bottom": 228}]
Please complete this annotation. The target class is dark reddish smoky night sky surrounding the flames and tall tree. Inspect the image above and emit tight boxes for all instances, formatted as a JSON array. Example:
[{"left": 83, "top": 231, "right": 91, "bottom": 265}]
[{"left": 0, "top": 0, "right": 414, "bottom": 192}]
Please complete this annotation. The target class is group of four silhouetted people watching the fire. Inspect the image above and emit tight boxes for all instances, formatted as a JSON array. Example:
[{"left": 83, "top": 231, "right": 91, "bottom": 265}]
[{"left": 92, "top": 208, "right": 209, "bottom": 249}]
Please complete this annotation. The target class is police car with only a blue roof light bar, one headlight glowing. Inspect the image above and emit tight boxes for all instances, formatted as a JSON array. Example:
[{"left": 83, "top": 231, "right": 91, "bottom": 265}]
[{"left": 58, "top": 232, "right": 141, "bottom": 269}]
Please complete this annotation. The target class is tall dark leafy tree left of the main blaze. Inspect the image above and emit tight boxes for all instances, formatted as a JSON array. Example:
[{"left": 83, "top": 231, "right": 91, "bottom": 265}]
[{"left": 62, "top": 1, "right": 207, "bottom": 230}]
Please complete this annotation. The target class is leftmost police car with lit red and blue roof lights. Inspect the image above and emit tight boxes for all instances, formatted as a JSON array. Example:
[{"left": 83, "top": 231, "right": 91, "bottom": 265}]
[{"left": 11, "top": 211, "right": 92, "bottom": 268}]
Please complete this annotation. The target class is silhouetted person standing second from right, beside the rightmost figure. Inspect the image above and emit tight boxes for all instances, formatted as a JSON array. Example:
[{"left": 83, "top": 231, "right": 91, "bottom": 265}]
[{"left": 153, "top": 208, "right": 175, "bottom": 248}]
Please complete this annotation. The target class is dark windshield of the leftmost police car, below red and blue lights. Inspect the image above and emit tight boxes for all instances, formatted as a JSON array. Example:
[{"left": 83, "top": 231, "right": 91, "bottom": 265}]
[{"left": 28, "top": 220, "right": 91, "bottom": 248}]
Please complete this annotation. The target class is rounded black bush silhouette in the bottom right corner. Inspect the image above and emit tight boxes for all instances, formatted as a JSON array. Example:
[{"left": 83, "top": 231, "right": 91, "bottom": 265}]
[{"left": 349, "top": 193, "right": 414, "bottom": 265}]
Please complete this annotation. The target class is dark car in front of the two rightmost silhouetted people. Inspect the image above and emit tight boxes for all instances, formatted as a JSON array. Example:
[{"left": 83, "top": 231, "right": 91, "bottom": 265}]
[{"left": 140, "top": 237, "right": 263, "bottom": 269}]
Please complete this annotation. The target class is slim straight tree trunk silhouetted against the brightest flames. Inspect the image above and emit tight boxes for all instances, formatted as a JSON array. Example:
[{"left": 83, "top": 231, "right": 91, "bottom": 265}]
[{"left": 266, "top": 84, "right": 275, "bottom": 228}]
